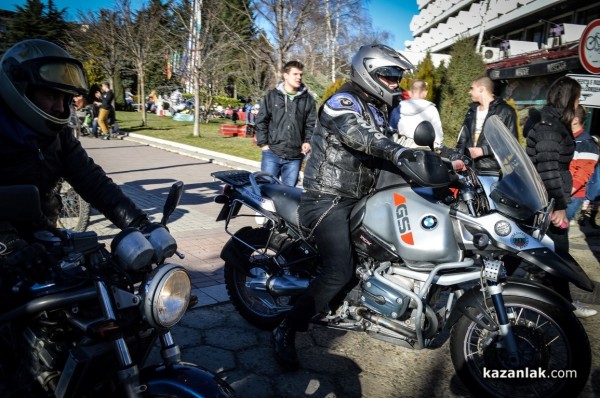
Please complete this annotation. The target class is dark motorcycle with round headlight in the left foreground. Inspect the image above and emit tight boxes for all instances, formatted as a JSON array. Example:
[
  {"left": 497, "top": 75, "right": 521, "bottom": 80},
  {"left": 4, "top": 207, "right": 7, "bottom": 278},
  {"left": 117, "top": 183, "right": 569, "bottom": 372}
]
[{"left": 0, "top": 182, "right": 235, "bottom": 398}]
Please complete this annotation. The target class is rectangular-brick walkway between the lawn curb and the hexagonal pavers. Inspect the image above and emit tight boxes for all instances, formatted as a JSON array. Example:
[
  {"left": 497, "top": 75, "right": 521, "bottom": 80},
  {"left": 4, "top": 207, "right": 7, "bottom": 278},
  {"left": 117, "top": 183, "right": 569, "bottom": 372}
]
[{"left": 81, "top": 137, "right": 259, "bottom": 306}]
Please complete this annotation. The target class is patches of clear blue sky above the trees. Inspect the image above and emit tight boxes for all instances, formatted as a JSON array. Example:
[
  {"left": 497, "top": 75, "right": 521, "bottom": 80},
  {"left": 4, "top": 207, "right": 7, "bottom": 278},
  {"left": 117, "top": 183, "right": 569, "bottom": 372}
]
[{"left": 5, "top": 0, "right": 419, "bottom": 50}]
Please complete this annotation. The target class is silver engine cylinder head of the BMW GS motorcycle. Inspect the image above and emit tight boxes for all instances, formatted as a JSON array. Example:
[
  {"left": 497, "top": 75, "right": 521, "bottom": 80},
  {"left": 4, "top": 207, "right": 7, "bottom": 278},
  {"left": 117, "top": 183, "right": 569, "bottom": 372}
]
[{"left": 360, "top": 275, "right": 411, "bottom": 319}]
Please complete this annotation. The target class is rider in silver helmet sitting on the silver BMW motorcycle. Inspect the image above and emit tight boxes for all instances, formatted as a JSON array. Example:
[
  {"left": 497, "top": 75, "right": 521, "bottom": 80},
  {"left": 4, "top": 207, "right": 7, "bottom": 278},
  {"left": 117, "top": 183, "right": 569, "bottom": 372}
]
[{"left": 273, "top": 44, "right": 460, "bottom": 368}]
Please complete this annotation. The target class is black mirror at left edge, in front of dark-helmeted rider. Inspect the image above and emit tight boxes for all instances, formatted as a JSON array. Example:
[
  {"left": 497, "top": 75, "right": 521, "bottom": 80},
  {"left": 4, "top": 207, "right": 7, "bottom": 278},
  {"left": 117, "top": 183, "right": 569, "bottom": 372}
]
[{"left": 0, "top": 185, "right": 44, "bottom": 222}]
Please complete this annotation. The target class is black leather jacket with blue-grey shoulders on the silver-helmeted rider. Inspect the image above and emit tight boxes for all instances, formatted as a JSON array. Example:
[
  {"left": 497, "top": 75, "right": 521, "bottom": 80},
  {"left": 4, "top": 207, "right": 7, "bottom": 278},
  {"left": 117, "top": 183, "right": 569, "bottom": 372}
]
[{"left": 304, "top": 83, "right": 403, "bottom": 199}]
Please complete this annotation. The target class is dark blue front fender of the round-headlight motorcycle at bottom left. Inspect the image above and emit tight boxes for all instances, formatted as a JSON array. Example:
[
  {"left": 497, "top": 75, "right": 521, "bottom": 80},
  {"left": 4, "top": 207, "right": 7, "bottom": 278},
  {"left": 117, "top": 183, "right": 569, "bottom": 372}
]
[{"left": 141, "top": 363, "right": 236, "bottom": 398}]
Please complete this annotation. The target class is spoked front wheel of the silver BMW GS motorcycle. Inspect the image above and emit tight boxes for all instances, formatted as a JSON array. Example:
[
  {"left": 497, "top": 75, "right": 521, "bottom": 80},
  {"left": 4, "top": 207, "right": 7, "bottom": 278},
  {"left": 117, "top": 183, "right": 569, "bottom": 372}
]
[{"left": 450, "top": 296, "right": 591, "bottom": 398}]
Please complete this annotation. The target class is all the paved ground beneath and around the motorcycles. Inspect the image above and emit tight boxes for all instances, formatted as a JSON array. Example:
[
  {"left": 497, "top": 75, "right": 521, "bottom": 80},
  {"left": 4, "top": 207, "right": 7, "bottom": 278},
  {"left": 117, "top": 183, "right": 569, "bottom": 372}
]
[{"left": 82, "top": 134, "right": 600, "bottom": 398}]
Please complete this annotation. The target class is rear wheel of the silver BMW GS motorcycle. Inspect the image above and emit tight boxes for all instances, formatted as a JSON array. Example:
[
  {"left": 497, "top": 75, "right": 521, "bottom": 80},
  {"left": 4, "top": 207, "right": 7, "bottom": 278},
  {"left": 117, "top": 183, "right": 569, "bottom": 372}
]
[{"left": 224, "top": 228, "right": 291, "bottom": 330}]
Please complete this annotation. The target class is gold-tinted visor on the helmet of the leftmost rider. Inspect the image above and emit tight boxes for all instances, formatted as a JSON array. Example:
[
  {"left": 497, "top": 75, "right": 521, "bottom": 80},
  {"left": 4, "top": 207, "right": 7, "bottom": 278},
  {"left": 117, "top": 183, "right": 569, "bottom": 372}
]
[{"left": 22, "top": 57, "right": 88, "bottom": 95}]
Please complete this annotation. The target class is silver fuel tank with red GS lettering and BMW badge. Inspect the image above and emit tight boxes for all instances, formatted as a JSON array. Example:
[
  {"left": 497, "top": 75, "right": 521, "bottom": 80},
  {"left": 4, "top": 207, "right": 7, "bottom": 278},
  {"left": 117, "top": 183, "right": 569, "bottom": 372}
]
[{"left": 362, "top": 186, "right": 460, "bottom": 263}]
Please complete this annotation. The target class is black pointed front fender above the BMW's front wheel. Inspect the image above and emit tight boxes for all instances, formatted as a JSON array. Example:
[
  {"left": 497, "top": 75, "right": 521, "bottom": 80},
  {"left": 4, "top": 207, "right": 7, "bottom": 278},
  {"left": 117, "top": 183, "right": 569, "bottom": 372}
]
[{"left": 517, "top": 248, "right": 594, "bottom": 292}]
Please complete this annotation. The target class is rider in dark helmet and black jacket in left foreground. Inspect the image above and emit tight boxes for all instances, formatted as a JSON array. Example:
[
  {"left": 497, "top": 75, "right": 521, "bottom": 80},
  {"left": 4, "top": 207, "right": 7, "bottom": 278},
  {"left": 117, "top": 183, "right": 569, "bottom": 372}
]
[{"left": 0, "top": 39, "right": 148, "bottom": 244}]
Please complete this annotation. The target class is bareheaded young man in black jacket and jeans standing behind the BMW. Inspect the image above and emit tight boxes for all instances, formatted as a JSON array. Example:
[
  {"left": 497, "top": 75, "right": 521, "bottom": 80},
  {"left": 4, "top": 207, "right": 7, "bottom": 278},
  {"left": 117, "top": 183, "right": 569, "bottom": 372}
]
[{"left": 255, "top": 61, "right": 317, "bottom": 186}]
